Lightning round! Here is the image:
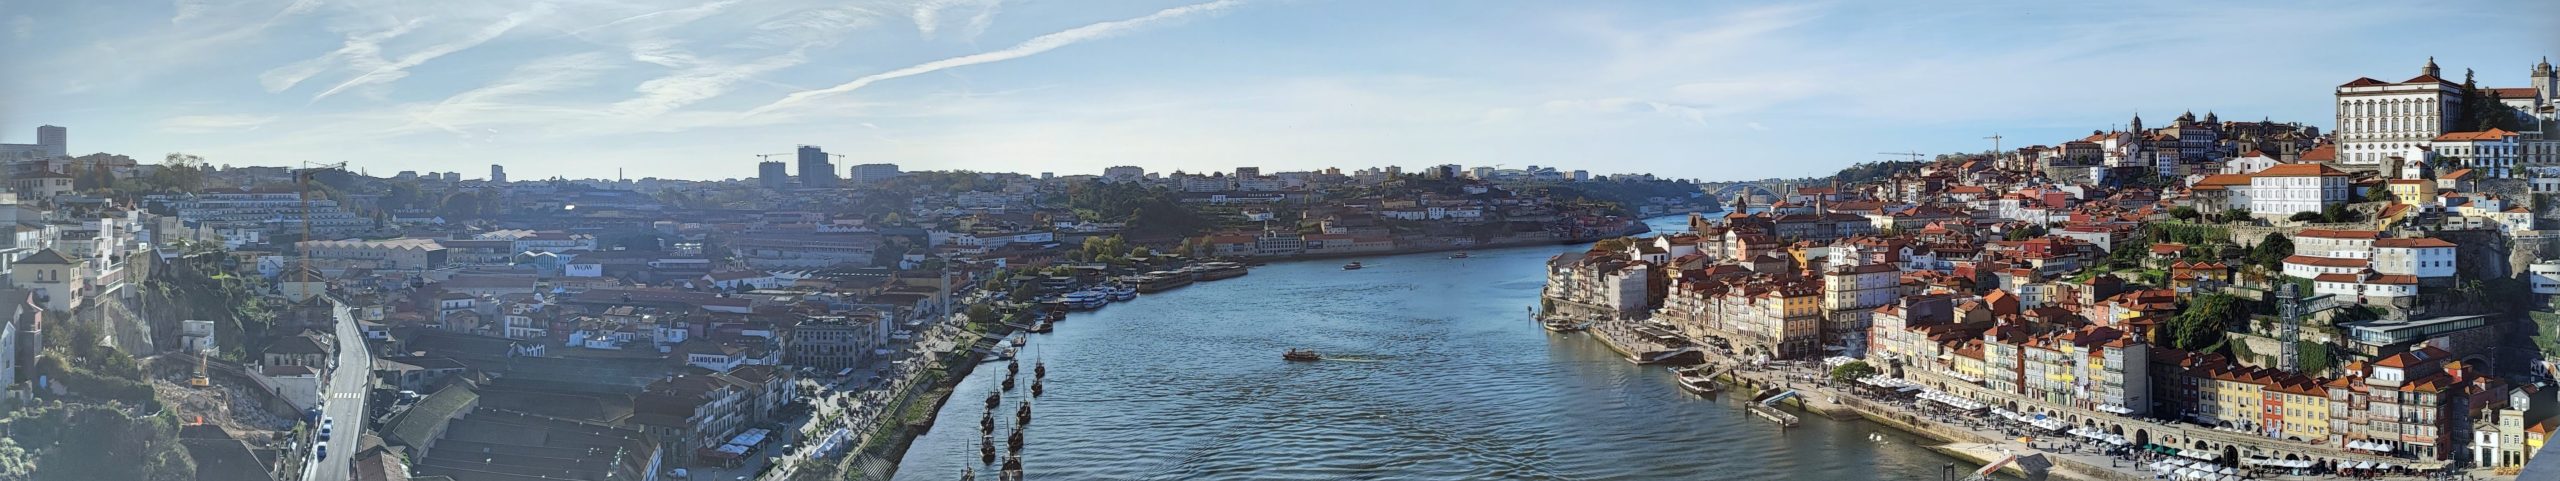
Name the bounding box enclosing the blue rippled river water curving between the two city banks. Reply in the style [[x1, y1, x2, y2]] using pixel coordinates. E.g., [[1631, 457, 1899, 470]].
[[899, 217, 1974, 481]]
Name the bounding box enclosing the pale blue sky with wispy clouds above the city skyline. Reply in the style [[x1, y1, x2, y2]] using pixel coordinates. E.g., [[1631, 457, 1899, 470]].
[[0, 0, 2560, 179]]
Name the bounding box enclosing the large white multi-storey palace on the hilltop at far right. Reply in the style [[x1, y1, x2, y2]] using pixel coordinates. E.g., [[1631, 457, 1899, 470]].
[[2337, 59, 2463, 166]]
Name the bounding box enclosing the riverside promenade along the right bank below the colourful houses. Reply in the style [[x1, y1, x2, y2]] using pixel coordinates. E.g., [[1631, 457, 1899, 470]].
[[1587, 320, 2499, 481]]
